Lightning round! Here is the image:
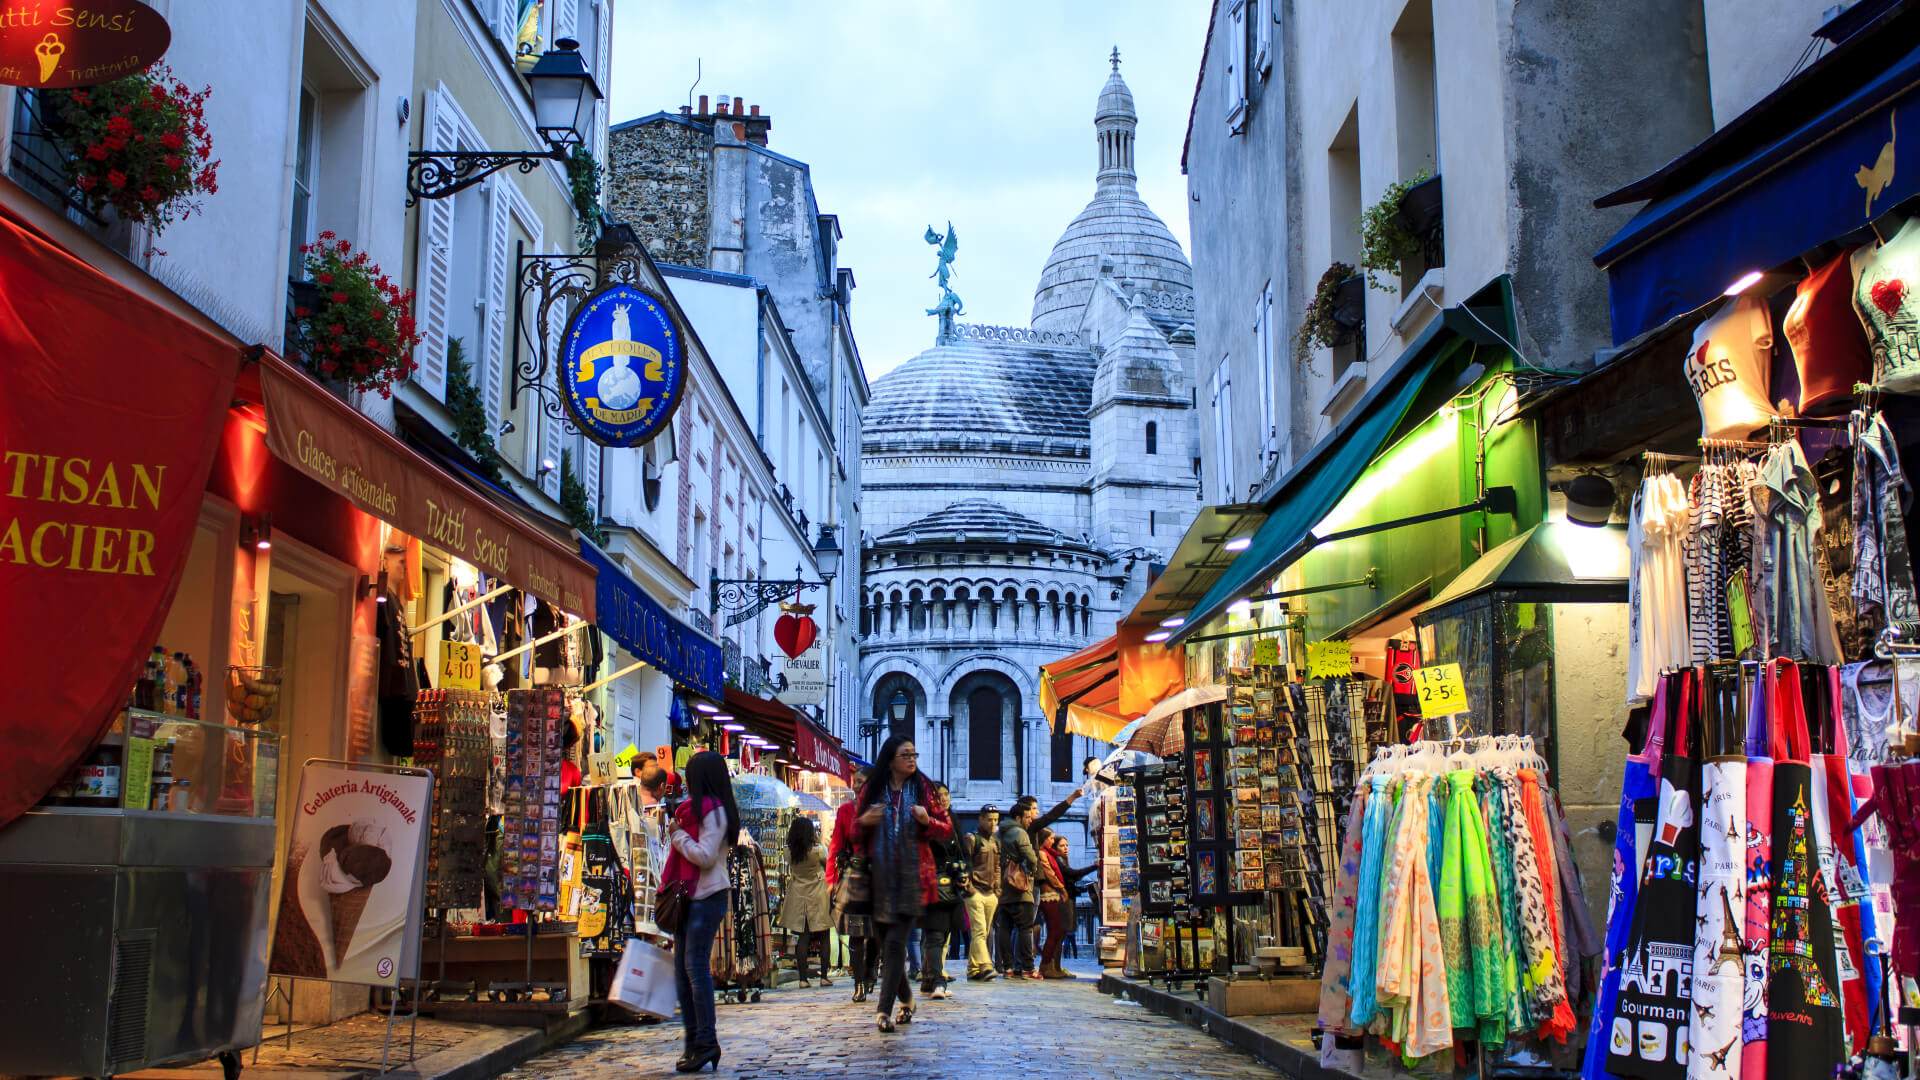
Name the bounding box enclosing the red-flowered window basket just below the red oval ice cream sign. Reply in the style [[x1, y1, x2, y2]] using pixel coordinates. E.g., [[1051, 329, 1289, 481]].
[[42, 65, 221, 234]]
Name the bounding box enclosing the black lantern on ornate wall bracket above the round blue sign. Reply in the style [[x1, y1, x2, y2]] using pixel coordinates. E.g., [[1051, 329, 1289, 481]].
[[407, 38, 601, 206]]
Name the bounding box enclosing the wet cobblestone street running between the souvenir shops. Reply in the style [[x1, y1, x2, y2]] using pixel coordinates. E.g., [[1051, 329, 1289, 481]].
[[505, 965, 1277, 1080]]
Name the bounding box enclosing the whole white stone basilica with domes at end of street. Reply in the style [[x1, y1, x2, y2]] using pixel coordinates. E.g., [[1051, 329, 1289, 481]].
[[854, 54, 1200, 822]]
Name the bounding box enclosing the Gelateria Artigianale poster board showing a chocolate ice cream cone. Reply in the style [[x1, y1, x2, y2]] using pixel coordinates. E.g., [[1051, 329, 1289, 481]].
[[267, 761, 434, 986]]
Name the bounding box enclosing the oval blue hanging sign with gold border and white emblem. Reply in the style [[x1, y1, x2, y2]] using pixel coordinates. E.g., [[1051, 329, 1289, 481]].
[[559, 284, 687, 446]]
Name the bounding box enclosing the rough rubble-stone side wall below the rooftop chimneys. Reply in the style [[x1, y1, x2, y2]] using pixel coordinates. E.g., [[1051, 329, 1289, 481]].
[[607, 117, 712, 267]]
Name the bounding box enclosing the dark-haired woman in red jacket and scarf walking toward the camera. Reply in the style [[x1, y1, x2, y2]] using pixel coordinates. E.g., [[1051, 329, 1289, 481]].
[[856, 734, 954, 1032]]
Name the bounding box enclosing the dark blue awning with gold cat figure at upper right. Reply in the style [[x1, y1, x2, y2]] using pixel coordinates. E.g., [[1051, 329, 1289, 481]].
[[1594, 36, 1920, 344]]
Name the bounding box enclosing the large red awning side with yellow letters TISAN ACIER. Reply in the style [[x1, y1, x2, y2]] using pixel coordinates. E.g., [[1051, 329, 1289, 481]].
[[0, 203, 240, 826]]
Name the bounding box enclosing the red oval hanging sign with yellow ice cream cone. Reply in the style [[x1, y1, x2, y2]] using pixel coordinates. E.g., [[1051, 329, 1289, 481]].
[[0, 0, 173, 90]]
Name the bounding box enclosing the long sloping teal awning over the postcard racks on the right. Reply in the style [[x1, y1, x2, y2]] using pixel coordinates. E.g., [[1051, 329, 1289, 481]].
[[1169, 281, 1511, 644]]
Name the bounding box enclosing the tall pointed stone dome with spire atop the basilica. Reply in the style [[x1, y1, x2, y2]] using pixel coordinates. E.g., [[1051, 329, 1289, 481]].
[[1033, 50, 1194, 331]]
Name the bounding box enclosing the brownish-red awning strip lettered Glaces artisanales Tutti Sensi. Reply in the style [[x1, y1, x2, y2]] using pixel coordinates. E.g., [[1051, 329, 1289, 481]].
[[259, 354, 595, 623]]
